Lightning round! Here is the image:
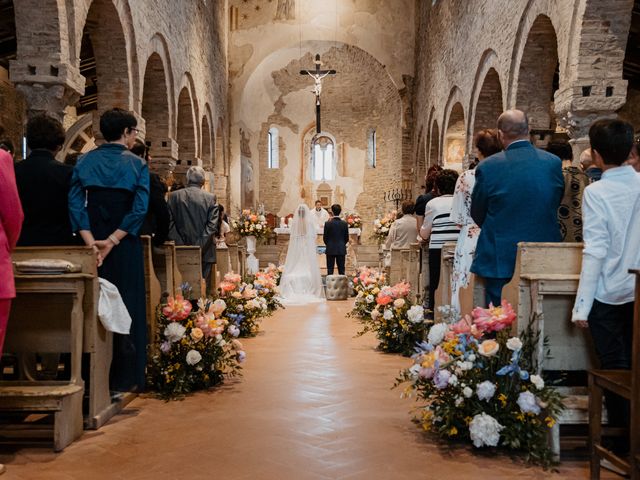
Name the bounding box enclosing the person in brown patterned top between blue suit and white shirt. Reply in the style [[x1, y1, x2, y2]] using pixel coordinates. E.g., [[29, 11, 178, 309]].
[[547, 142, 590, 243]]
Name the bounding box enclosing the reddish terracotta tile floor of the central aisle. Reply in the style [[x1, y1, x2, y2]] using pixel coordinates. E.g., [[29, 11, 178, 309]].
[[0, 302, 604, 480]]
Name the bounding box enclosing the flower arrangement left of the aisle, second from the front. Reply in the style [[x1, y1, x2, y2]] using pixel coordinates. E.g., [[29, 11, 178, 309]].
[[218, 273, 269, 337]]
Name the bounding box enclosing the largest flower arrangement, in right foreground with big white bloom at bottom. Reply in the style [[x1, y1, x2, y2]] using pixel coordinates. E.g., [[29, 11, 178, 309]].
[[396, 301, 563, 466]]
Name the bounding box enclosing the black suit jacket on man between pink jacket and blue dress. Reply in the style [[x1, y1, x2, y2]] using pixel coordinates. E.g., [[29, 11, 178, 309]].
[[15, 150, 83, 246]]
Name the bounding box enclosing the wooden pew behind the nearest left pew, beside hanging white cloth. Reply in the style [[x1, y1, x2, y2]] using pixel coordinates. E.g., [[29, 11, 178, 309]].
[[12, 246, 117, 428]]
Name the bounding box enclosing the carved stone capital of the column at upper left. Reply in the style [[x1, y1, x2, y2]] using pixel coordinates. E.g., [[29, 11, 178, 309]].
[[10, 58, 85, 121]]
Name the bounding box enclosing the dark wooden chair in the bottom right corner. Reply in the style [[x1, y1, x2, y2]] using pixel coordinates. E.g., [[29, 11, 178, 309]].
[[589, 269, 640, 480]]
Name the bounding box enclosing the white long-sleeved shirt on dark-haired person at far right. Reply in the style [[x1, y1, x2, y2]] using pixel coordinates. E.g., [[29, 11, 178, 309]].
[[572, 166, 640, 321]]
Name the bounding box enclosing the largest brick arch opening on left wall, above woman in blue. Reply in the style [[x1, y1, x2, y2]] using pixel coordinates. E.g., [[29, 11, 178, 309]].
[[76, 0, 137, 117]]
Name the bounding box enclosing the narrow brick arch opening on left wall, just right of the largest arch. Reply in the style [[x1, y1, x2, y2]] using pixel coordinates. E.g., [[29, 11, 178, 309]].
[[141, 52, 176, 173]]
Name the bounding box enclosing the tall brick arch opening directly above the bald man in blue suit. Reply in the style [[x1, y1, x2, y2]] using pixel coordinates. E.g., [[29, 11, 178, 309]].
[[515, 15, 559, 132]]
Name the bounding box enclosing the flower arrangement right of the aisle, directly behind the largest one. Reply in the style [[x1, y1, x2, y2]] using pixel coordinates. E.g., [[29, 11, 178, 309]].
[[357, 282, 428, 356]]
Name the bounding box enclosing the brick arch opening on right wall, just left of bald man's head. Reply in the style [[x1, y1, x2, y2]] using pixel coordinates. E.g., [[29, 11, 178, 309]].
[[467, 49, 504, 148]]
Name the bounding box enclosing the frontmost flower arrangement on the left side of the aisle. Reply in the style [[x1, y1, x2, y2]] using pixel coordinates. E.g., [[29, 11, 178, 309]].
[[147, 295, 246, 400]]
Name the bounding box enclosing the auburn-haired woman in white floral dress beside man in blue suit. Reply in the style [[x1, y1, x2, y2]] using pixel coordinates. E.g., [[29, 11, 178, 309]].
[[451, 130, 502, 313]]
